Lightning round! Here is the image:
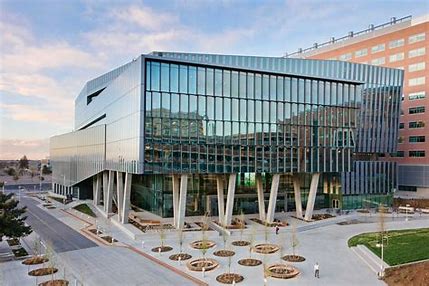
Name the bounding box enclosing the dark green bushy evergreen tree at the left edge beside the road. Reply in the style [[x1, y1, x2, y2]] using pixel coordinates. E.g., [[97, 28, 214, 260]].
[[0, 193, 32, 241]]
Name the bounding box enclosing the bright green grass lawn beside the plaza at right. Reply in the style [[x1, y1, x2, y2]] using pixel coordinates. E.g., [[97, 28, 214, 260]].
[[348, 228, 429, 266]]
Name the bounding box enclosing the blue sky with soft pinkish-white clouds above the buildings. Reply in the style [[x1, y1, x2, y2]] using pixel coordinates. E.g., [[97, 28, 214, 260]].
[[0, 0, 429, 159]]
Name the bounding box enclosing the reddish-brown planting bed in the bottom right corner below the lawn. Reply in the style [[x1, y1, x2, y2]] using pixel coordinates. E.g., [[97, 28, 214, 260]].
[[384, 262, 429, 286]]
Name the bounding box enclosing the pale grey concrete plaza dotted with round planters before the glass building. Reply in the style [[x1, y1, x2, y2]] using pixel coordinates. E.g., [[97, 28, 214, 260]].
[[0, 193, 429, 285]]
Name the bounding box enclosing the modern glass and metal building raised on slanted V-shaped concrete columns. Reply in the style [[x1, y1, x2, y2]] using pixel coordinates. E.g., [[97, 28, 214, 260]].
[[51, 52, 403, 227]]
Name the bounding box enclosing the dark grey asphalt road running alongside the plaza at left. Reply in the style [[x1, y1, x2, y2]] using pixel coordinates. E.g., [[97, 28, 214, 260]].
[[20, 196, 97, 253]]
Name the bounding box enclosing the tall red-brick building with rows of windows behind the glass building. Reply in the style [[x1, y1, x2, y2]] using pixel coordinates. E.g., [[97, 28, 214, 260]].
[[286, 15, 429, 197]]
